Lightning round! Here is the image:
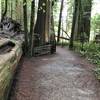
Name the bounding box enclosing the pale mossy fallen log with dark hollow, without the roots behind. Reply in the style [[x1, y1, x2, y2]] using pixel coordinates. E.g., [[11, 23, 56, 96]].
[[0, 38, 22, 100]]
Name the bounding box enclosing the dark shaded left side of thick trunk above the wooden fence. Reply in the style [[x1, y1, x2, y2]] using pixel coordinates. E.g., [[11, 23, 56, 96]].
[[34, 0, 47, 45]]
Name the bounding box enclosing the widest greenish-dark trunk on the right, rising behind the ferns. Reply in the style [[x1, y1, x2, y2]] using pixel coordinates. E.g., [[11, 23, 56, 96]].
[[74, 0, 92, 40]]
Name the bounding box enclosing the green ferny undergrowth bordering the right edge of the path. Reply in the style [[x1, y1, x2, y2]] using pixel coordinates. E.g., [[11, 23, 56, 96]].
[[75, 43, 100, 79]]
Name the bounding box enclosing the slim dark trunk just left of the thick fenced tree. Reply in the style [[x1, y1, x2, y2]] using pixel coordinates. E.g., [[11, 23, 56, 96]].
[[29, 0, 35, 56]]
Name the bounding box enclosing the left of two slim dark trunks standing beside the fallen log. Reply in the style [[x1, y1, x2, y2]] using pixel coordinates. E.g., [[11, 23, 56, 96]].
[[23, 0, 28, 55]]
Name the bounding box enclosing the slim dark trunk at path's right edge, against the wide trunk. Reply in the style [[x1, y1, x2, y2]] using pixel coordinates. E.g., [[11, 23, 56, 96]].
[[69, 0, 78, 49]]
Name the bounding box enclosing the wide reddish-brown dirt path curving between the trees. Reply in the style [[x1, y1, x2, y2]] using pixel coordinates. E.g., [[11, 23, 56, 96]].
[[10, 47, 100, 100]]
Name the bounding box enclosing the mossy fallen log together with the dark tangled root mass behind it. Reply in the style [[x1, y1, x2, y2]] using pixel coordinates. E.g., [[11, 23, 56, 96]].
[[0, 17, 24, 100]]
